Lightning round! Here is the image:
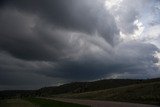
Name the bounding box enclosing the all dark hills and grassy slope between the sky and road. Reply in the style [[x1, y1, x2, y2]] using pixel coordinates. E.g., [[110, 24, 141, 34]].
[[0, 78, 160, 107]]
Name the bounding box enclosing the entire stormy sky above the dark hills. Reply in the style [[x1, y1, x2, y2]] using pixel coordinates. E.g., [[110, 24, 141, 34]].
[[0, 0, 160, 90]]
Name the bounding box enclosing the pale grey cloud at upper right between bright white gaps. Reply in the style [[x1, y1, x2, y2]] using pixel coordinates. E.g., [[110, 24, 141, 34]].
[[109, 0, 151, 36]]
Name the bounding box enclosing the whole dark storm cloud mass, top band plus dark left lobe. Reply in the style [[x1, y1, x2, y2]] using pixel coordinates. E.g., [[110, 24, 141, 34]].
[[0, 0, 118, 60]]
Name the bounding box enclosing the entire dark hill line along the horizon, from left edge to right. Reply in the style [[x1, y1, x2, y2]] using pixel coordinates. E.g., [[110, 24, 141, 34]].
[[0, 78, 160, 99]]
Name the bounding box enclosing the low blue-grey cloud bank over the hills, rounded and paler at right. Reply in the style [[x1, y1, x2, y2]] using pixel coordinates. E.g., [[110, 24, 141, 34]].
[[37, 42, 159, 81]]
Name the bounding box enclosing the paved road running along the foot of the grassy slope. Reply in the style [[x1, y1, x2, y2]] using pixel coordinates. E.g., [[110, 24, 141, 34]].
[[48, 99, 160, 107]]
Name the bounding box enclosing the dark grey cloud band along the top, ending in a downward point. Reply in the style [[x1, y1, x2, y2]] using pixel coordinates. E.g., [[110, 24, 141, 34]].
[[1, 0, 118, 44]]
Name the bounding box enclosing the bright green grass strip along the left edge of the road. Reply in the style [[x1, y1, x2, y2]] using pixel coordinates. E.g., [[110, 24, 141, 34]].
[[27, 98, 88, 107]]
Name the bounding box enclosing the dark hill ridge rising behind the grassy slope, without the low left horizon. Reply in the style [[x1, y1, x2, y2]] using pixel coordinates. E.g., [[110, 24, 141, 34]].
[[36, 78, 160, 96]]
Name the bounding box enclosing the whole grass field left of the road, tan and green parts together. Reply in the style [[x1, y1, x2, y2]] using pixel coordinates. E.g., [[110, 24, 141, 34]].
[[0, 98, 88, 107]]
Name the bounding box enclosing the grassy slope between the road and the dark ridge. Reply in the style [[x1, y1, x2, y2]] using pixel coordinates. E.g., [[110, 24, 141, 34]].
[[56, 82, 160, 105]]
